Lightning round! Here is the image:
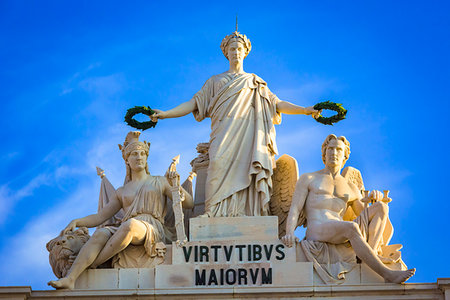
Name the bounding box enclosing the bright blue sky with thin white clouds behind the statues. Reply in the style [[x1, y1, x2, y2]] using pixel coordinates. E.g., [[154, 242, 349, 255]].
[[0, 1, 450, 289]]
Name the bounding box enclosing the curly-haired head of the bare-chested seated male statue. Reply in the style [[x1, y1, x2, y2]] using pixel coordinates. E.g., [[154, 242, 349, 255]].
[[322, 134, 350, 168]]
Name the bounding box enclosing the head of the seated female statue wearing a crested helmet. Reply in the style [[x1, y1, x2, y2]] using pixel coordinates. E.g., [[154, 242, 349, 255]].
[[119, 131, 150, 183]]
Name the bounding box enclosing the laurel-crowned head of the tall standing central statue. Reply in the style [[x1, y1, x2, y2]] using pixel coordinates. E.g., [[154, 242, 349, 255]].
[[220, 31, 252, 62]]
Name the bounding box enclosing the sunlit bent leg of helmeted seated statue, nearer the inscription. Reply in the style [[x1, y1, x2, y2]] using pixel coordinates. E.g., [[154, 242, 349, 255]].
[[92, 219, 147, 267]]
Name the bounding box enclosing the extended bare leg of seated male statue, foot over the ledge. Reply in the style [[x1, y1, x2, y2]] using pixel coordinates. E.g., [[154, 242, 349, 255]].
[[307, 221, 416, 283]]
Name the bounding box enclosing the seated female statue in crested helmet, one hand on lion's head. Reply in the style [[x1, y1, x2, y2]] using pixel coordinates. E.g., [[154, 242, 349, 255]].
[[48, 131, 193, 289]]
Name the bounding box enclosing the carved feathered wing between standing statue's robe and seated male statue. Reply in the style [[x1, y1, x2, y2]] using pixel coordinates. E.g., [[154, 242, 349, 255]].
[[270, 154, 298, 237]]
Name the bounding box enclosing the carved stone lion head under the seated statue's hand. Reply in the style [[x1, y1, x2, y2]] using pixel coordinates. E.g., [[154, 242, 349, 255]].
[[47, 227, 89, 278]]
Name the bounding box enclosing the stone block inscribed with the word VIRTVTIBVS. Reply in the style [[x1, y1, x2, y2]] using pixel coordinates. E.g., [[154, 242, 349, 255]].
[[172, 239, 296, 265]]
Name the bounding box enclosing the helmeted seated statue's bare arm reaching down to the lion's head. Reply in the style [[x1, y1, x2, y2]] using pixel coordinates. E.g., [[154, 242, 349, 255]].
[[64, 189, 122, 232]]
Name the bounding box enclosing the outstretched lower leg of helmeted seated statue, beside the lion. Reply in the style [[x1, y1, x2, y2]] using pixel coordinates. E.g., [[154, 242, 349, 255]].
[[48, 228, 111, 289]]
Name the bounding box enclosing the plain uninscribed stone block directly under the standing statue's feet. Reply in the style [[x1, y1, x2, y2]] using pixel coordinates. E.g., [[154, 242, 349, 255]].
[[189, 216, 278, 241]]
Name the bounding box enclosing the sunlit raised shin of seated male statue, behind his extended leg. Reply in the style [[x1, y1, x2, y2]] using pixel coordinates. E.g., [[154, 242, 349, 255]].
[[367, 202, 389, 252]]
